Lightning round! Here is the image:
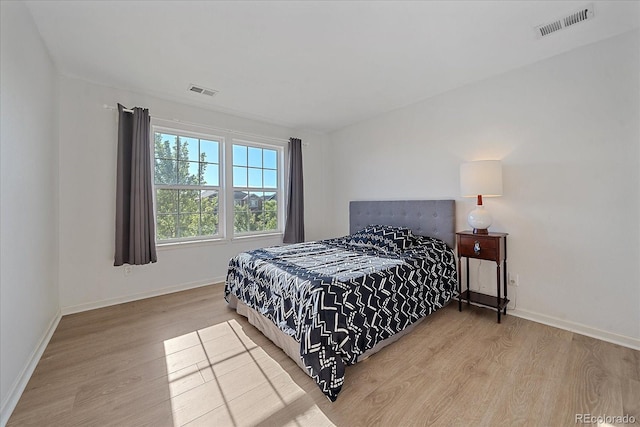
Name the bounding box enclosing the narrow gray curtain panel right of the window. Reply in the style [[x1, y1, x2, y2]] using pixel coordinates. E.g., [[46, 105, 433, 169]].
[[283, 138, 304, 243]]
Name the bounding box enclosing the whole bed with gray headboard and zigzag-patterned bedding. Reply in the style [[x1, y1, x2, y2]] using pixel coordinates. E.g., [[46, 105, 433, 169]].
[[225, 200, 457, 401]]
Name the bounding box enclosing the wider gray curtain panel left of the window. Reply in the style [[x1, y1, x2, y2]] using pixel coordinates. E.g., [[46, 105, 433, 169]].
[[113, 104, 158, 266]]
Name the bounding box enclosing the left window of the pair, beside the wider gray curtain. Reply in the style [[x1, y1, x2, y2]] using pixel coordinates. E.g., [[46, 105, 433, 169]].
[[154, 131, 222, 241]]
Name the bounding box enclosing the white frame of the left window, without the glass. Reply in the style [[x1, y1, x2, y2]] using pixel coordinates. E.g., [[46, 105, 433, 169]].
[[150, 124, 226, 246]]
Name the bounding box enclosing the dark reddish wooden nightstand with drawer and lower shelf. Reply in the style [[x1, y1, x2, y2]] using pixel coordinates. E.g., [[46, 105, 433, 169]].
[[456, 231, 509, 323]]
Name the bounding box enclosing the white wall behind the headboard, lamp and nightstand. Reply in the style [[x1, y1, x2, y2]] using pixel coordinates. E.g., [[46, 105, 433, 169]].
[[329, 31, 640, 346]]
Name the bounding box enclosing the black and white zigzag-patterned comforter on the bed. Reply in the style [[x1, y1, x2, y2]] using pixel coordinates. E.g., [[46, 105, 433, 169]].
[[225, 235, 457, 401]]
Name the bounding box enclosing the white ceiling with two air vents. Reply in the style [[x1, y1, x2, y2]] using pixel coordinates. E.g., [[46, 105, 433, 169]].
[[26, 0, 640, 132]]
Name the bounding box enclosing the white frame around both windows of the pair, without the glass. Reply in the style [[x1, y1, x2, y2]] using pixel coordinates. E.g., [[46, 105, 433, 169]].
[[149, 118, 289, 247]]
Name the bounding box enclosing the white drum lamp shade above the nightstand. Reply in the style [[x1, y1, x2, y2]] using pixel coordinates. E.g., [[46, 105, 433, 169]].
[[460, 160, 502, 197]]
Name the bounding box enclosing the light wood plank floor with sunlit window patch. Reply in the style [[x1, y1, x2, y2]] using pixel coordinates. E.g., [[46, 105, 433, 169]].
[[8, 285, 640, 426]]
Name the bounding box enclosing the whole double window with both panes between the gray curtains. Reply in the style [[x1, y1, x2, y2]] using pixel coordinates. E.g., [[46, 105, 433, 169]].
[[153, 123, 286, 243]]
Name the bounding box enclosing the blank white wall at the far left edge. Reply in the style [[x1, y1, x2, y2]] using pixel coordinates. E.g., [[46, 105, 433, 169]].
[[0, 1, 59, 425]]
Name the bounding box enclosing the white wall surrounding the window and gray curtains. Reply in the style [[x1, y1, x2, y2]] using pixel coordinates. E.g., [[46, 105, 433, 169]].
[[60, 77, 326, 313]]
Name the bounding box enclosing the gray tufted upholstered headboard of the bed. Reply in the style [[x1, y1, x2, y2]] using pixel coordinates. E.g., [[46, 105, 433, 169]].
[[349, 200, 456, 248]]
